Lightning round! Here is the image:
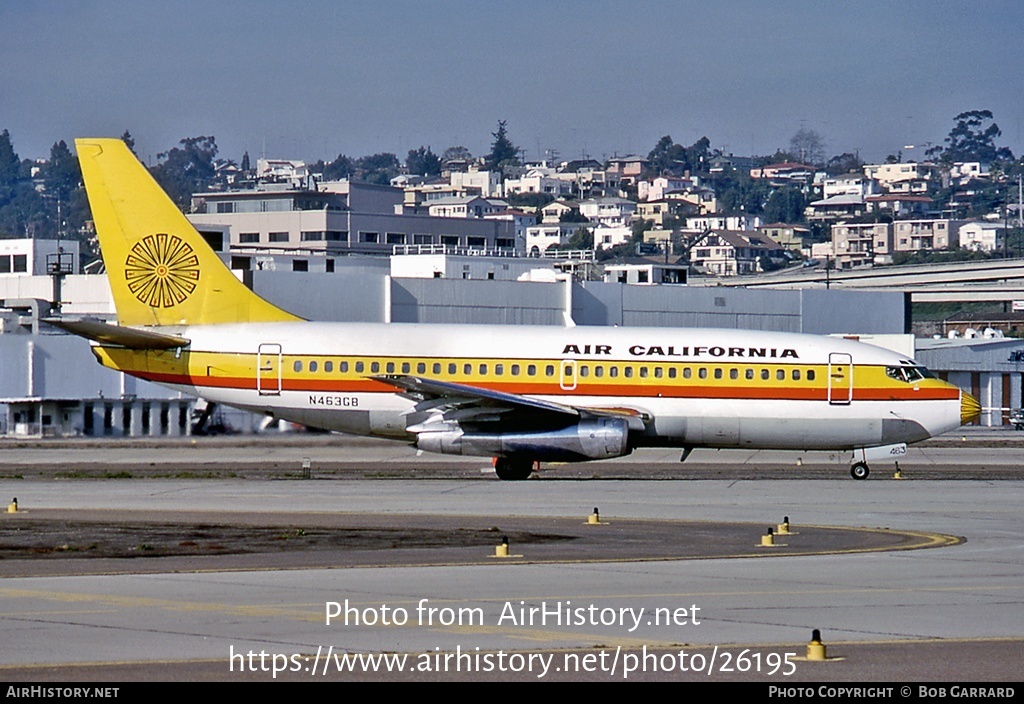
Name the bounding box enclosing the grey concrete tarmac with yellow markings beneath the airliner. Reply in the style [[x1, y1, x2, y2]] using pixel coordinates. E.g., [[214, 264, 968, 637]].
[[0, 434, 1024, 686]]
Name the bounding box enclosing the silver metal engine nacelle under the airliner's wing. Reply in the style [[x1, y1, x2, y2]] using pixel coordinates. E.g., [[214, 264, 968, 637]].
[[416, 417, 632, 461]]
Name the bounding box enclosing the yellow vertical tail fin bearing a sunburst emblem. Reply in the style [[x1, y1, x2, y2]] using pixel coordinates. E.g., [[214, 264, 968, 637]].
[[75, 139, 301, 325]]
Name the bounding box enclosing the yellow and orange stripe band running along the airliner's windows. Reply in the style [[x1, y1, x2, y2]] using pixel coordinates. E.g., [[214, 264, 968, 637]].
[[95, 347, 956, 401]]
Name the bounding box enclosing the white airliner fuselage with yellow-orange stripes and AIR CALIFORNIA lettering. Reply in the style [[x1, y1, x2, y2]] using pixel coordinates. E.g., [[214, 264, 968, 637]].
[[103, 322, 961, 449]]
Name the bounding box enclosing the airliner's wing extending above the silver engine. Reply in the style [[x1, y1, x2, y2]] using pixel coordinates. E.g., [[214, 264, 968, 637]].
[[373, 375, 649, 432]]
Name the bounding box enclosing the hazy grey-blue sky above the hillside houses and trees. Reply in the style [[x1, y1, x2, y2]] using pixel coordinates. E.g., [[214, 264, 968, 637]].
[[0, 0, 1024, 166]]
